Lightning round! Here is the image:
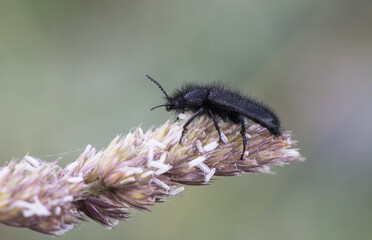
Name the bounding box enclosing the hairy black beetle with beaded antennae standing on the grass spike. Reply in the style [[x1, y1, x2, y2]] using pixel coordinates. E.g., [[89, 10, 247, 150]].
[[146, 75, 281, 160]]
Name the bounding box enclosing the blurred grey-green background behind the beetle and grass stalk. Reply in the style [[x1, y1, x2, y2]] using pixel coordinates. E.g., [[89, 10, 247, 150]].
[[0, 0, 372, 240]]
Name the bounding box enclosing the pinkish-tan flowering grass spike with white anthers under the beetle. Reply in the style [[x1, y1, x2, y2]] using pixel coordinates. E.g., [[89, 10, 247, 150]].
[[0, 115, 303, 235]]
